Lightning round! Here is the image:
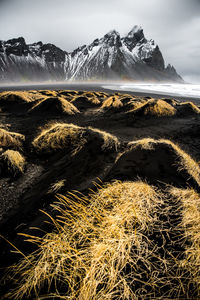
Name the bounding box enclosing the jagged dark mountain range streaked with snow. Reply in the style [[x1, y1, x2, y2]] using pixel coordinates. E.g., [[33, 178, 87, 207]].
[[0, 26, 182, 82]]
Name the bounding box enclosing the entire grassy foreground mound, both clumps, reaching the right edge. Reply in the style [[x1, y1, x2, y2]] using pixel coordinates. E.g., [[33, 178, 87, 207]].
[[6, 181, 200, 300]]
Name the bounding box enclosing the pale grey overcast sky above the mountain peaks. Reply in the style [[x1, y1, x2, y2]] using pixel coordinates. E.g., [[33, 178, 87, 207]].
[[0, 0, 200, 84]]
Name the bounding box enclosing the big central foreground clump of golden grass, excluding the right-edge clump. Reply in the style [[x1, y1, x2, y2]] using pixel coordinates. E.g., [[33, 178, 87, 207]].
[[6, 182, 166, 300]]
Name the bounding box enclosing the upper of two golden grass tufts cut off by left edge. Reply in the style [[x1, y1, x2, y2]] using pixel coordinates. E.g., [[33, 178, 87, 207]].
[[0, 128, 25, 148]]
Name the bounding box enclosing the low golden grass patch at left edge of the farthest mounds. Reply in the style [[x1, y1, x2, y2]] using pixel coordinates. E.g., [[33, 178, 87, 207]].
[[0, 91, 41, 103]]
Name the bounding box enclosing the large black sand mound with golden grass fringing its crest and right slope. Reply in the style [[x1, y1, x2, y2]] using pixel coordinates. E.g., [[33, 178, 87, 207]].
[[107, 138, 200, 188]]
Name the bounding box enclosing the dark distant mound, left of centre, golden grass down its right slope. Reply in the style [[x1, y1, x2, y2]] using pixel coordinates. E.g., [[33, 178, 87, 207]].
[[29, 97, 79, 115]]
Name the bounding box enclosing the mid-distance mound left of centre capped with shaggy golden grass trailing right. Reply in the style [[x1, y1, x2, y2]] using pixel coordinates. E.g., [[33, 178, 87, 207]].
[[32, 123, 119, 154]]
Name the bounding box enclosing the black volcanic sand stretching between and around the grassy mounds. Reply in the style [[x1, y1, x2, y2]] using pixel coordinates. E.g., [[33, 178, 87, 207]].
[[0, 87, 200, 298]]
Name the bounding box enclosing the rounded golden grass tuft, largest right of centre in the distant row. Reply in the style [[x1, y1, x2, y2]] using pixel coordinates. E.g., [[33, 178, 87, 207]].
[[130, 99, 176, 117]]
